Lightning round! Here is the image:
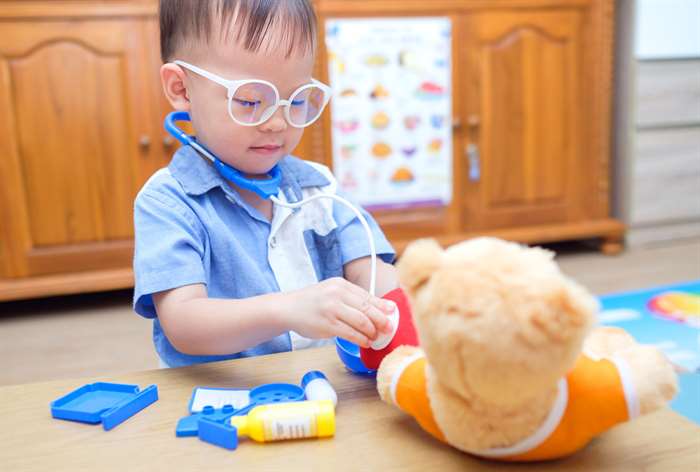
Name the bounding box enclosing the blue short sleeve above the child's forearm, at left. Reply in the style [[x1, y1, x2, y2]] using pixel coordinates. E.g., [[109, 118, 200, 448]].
[[134, 192, 206, 318]]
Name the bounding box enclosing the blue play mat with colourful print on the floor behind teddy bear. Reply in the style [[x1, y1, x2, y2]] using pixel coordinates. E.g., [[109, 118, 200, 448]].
[[598, 280, 700, 424]]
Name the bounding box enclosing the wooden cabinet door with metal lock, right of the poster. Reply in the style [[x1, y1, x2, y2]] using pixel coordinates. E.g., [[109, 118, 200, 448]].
[[461, 7, 588, 230]]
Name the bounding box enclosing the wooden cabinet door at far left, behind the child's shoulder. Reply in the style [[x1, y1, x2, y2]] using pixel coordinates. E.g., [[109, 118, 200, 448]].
[[0, 18, 150, 277]]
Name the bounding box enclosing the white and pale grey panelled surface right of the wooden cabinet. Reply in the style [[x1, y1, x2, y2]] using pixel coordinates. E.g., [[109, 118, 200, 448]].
[[628, 0, 700, 245]]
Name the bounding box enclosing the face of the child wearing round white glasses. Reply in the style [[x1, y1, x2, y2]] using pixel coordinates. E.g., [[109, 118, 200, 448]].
[[171, 36, 313, 175]]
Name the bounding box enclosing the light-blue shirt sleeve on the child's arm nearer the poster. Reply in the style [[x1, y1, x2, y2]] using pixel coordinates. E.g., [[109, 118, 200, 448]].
[[333, 192, 396, 265]]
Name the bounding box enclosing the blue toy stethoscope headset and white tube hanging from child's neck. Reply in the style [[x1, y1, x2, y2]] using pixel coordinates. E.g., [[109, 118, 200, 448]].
[[163, 111, 377, 296]]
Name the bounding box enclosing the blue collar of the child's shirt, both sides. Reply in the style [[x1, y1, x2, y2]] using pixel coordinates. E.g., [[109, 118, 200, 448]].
[[168, 146, 330, 198]]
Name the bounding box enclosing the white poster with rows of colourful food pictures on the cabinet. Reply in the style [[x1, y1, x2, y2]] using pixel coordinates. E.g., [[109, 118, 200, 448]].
[[325, 17, 452, 209]]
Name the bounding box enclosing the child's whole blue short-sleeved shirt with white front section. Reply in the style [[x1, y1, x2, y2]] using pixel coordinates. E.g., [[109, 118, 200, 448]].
[[134, 146, 395, 367]]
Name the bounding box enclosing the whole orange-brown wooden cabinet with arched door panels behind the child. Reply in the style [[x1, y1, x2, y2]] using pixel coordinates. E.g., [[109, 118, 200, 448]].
[[0, 0, 623, 300]]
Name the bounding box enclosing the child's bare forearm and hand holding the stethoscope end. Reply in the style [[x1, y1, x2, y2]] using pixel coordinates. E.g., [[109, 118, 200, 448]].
[[153, 278, 394, 355]]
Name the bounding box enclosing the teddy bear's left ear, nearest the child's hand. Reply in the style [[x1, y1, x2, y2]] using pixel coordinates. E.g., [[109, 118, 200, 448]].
[[397, 239, 444, 292]]
